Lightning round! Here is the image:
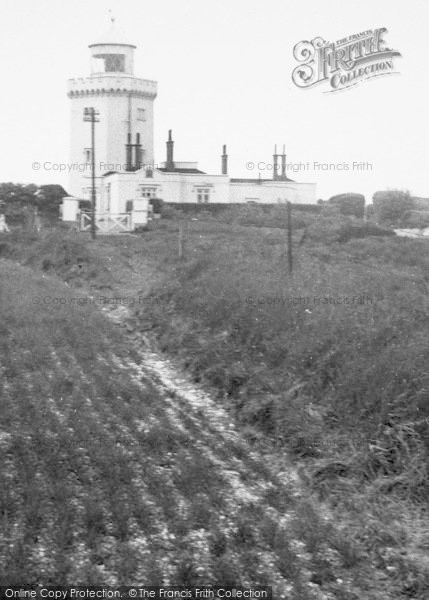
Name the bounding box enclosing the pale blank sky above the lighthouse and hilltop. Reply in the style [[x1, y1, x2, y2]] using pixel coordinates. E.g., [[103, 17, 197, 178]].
[[0, 0, 429, 202]]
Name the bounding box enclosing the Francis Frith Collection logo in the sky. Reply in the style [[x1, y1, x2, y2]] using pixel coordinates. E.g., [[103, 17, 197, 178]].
[[292, 27, 401, 93]]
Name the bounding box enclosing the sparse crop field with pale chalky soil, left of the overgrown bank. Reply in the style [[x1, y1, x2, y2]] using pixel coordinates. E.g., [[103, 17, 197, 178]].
[[0, 260, 368, 598]]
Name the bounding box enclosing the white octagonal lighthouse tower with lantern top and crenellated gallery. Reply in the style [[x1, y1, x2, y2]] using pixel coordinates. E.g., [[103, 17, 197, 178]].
[[68, 18, 157, 203]]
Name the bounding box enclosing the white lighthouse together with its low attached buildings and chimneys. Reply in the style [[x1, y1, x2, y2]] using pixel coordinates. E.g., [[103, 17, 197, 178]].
[[68, 20, 316, 227]]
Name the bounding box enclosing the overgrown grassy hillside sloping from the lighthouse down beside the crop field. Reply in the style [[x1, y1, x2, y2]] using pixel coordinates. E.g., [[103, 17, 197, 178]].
[[2, 213, 429, 600]]
